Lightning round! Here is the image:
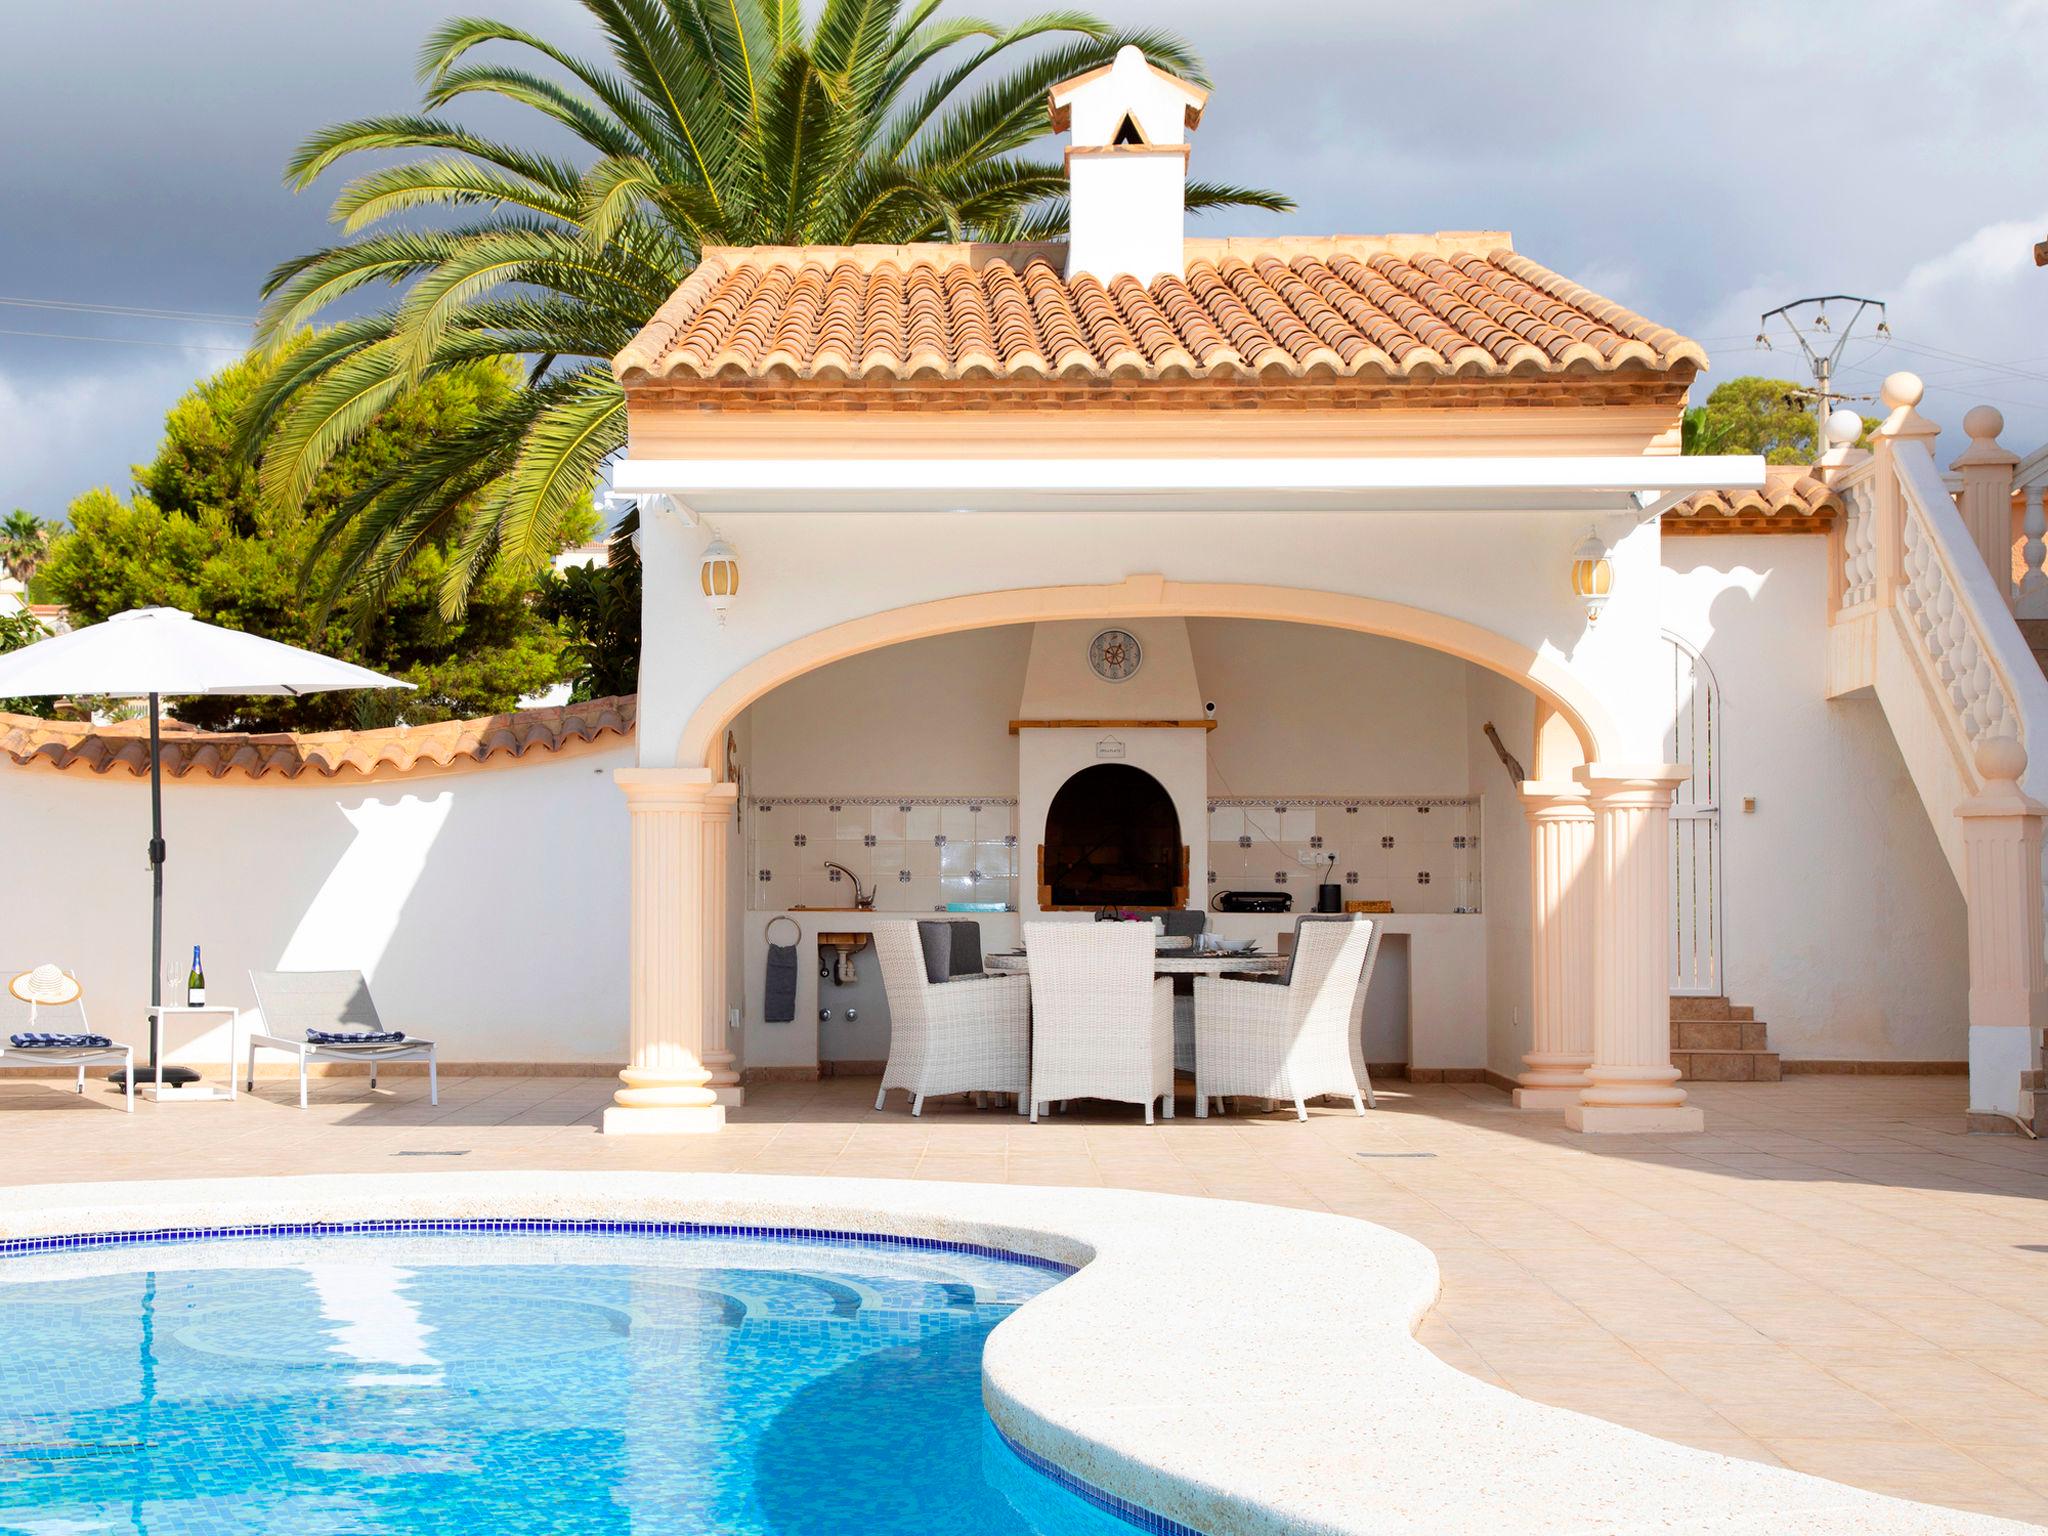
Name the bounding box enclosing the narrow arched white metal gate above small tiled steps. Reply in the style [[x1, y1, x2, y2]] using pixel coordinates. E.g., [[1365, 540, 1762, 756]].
[[1665, 633, 1726, 997]]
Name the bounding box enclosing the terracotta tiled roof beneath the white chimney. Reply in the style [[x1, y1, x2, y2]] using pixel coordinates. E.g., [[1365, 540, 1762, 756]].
[[612, 233, 1706, 387]]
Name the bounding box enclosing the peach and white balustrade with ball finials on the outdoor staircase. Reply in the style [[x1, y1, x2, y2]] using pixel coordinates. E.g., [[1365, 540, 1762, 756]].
[[1821, 373, 2048, 1130]]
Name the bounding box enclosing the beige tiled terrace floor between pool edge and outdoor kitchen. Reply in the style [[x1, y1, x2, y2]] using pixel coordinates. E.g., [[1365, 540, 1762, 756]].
[[0, 1077, 2048, 1524]]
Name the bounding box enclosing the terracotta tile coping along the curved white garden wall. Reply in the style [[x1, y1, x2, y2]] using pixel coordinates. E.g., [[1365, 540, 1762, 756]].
[[0, 694, 635, 778]]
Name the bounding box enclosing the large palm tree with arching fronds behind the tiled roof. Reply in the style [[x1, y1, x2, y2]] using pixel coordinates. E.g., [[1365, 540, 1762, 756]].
[[244, 0, 1292, 614]]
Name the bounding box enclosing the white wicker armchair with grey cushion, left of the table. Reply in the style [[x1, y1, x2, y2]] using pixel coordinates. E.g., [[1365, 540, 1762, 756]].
[[874, 922, 1030, 1114]]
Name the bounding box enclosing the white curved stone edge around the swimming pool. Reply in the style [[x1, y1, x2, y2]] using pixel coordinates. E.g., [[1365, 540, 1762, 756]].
[[0, 1171, 2036, 1536]]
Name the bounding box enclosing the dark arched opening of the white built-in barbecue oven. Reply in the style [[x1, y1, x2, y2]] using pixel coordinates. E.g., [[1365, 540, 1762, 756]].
[[1038, 762, 1188, 911]]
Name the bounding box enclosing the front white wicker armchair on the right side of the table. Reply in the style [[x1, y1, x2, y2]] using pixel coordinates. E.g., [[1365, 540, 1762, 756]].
[[1194, 920, 1374, 1120]]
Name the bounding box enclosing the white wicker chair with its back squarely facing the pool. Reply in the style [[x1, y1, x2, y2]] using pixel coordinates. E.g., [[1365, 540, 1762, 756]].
[[1024, 924, 1174, 1124]]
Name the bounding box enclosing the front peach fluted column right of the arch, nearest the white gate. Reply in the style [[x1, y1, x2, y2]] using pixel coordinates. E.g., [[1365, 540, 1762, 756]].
[[1565, 764, 1706, 1130]]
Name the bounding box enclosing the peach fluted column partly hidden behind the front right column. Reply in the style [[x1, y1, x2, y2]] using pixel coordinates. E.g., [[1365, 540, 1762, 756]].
[[1516, 784, 1593, 1110]]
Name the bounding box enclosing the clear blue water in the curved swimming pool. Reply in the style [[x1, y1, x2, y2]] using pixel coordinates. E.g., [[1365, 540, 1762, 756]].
[[0, 1233, 1133, 1536]]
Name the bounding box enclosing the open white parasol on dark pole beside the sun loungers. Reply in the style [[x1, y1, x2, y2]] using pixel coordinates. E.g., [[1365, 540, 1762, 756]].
[[0, 608, 412, 1081]]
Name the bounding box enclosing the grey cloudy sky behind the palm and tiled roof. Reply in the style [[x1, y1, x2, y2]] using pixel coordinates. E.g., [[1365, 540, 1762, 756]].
[[0, 0, 2048, 516]]
